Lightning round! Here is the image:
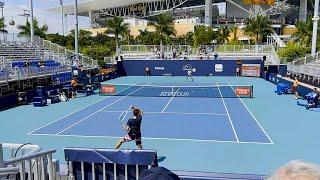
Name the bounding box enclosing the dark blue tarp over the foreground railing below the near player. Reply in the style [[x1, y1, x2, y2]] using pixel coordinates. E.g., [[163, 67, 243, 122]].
[[64, 148, 158, 180]]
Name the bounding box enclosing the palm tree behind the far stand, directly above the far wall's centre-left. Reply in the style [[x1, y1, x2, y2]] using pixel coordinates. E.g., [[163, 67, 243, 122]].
[[149, 13, 176, 52]]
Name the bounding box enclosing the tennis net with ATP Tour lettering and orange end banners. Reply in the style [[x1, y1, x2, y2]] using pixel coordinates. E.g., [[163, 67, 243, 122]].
[[100, 84, 253, 98]]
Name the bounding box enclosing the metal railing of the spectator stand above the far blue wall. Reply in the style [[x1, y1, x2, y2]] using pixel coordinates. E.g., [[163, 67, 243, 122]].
[[121, 45, 280, 65]]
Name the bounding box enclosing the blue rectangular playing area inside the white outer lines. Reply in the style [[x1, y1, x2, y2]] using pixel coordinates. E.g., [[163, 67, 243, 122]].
[[29, 79, 272, 144]]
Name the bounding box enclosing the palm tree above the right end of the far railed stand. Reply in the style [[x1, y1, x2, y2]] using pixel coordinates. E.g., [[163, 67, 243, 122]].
[[245, 15, 273, 44]]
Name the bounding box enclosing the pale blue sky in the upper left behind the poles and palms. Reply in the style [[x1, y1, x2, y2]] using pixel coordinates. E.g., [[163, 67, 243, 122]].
[[1, 0, 89, 34]]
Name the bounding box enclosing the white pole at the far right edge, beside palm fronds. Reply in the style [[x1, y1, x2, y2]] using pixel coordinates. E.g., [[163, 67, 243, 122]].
[[311, 0, 319, 56]]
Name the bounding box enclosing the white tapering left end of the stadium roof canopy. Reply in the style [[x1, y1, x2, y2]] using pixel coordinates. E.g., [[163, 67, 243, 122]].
[[47, 0, 163, 14]]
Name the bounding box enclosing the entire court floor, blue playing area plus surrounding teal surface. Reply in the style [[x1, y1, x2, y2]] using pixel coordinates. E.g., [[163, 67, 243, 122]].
[[0, 77, 320, 175]]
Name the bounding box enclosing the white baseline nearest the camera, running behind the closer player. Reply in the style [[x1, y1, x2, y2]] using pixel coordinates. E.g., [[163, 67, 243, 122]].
[[30, 134, 271, 145]]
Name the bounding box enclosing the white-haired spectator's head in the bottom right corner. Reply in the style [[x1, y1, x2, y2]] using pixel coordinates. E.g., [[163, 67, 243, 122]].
[[267, 161, 320, 180]]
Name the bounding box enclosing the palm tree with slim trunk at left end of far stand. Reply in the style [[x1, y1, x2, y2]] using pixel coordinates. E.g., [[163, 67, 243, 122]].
[[107, 17, 129, 56]]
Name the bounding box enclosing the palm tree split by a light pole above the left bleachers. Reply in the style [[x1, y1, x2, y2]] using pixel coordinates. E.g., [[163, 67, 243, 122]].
[[18, 19, 48, 38]]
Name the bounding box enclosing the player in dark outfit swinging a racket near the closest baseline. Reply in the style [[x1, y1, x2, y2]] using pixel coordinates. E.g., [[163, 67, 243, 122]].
[[115, 107, 143, 149]]
